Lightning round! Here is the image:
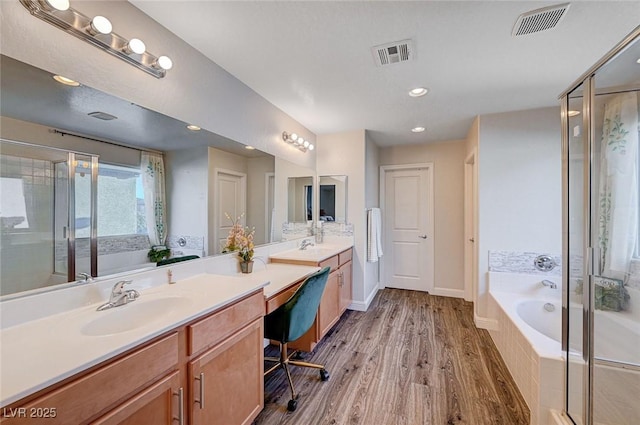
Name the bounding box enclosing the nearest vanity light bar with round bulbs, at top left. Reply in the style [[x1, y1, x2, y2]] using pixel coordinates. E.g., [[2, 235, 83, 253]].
[[20, 0, 173, 78]]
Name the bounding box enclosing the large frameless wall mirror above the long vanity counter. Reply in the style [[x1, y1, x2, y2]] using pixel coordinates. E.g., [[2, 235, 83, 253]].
[[0, 55, 286, 295]]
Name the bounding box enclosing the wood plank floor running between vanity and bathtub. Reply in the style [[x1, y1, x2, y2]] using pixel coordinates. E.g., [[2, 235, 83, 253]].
[[254, 289, 529, 425]]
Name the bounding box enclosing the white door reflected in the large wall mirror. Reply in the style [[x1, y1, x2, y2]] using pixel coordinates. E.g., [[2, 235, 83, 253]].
[[214, 169, 247, 254]]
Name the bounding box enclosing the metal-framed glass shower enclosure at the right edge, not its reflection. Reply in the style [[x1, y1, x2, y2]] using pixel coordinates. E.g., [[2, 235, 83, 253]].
[[561, 27, 640, 425]]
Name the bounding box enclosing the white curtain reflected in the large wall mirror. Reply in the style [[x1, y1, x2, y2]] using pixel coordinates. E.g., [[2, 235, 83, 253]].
[[140, 152, 167, 245]]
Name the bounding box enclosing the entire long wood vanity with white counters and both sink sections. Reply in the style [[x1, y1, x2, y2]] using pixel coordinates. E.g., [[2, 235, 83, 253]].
[[0, 240, 352, 425]]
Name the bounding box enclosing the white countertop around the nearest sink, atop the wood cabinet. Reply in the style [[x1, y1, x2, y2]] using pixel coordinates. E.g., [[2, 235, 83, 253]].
[[0, 273, 269, 406]]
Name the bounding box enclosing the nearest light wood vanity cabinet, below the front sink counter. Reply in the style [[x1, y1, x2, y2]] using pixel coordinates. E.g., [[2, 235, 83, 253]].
[[0, 290, 264, 425]]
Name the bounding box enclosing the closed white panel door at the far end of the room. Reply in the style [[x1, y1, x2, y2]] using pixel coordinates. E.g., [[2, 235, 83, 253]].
[[383, 166, 433, 292]]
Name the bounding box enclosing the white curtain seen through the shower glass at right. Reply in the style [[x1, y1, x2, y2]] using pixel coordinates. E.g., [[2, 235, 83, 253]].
[[598, 93, 638, 280]]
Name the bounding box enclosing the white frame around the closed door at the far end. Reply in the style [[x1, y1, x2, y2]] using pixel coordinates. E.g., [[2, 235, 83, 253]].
[[379, 162, 436, 294]]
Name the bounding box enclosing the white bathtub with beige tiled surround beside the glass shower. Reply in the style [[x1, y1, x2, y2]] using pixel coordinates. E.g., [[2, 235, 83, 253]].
[[489, 272, 640, 425]]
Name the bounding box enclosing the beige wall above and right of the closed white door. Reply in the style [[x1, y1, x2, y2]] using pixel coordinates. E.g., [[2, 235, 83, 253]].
[[380, 140, 467, 298]]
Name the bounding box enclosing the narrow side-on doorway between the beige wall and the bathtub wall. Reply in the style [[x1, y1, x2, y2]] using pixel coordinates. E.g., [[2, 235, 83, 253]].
[[464, 148, 479, 304]]
